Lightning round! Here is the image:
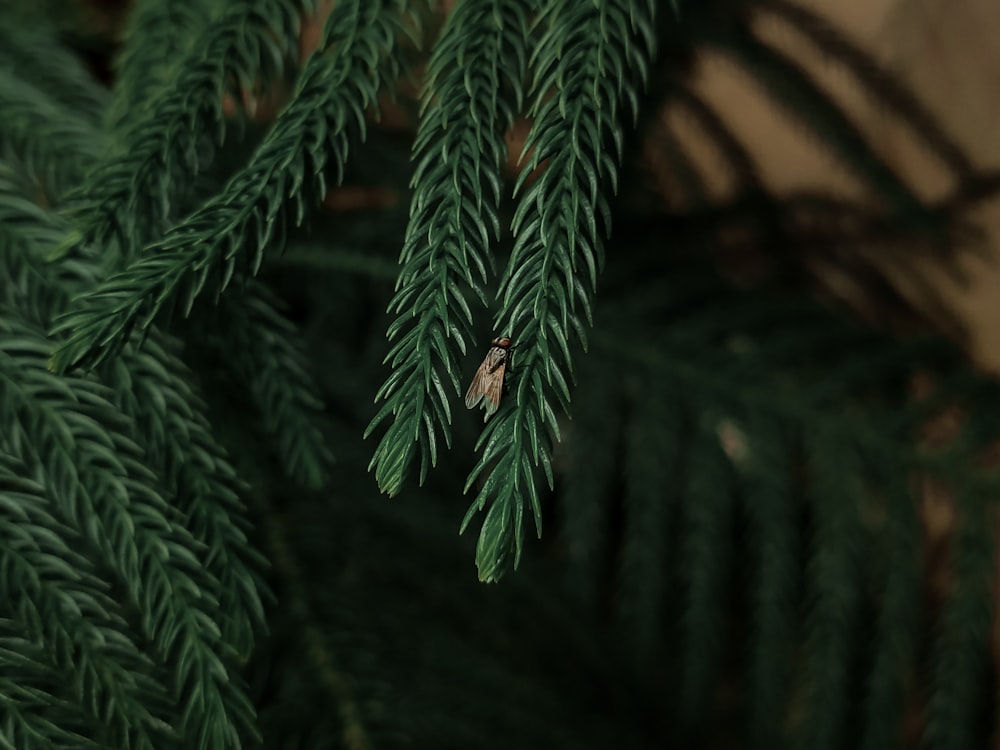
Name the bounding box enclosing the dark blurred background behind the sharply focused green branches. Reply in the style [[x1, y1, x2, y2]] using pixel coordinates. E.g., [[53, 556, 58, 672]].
[[0, 0, 1000, 750]]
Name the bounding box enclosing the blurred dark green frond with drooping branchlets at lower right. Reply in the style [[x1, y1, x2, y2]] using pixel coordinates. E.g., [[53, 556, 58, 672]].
[[584, 258, 1000, 747]]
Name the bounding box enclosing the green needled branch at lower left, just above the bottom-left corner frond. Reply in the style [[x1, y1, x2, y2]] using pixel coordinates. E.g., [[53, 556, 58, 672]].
[[0, 453, 167, 750]]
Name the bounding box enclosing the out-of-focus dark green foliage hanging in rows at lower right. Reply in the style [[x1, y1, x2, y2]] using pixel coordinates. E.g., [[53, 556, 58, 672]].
[[580, 267, 997, 747]]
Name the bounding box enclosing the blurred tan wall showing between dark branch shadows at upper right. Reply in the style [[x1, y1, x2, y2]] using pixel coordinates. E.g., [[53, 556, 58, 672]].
[[699, 0, 1000, 373]]
